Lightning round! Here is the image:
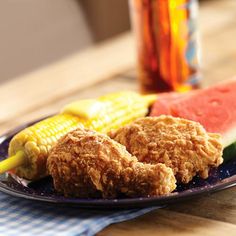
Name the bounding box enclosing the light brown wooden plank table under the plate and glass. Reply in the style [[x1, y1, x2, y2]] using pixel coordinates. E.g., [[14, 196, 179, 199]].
[[0, 0, 236, 236]]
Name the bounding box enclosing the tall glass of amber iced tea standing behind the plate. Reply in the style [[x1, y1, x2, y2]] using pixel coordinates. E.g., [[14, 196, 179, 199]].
[[130, 0, 201, 93]]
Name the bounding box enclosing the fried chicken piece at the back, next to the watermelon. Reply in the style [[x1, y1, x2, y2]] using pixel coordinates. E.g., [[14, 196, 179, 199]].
[[109, 115, 223, 183]]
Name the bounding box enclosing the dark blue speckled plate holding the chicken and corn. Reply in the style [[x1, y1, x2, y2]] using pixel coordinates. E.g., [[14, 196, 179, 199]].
[[0, 121, 236, 209]]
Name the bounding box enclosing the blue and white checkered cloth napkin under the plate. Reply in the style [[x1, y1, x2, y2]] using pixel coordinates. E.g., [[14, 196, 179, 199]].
[[0, 192, 155, 236]]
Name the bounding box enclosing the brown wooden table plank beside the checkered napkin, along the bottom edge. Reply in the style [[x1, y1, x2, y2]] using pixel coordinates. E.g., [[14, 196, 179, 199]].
[[98, 209, 236, 236]]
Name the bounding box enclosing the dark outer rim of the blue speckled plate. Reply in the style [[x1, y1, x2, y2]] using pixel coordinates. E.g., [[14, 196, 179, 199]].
[[0, 121, 236, 208]]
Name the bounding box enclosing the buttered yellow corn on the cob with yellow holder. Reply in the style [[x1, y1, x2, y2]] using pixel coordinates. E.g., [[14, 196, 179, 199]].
[[0, 92, 156, 180]]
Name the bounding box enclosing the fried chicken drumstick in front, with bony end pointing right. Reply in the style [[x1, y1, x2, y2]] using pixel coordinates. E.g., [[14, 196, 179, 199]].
[[47, 129, 176, 198]]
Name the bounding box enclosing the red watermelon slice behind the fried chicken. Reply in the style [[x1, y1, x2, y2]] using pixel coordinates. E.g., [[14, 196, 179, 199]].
[[151, 78, 236, 147]]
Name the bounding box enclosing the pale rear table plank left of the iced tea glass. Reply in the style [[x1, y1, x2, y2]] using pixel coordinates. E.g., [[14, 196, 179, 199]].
[[0, 34, 135, 124]]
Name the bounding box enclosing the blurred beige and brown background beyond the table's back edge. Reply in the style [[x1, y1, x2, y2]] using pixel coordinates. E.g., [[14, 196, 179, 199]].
[[0, 0, 236, 82]]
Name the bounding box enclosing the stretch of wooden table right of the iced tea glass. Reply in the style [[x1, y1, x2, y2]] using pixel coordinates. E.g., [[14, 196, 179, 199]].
[[199, 0, 236, 86]]
